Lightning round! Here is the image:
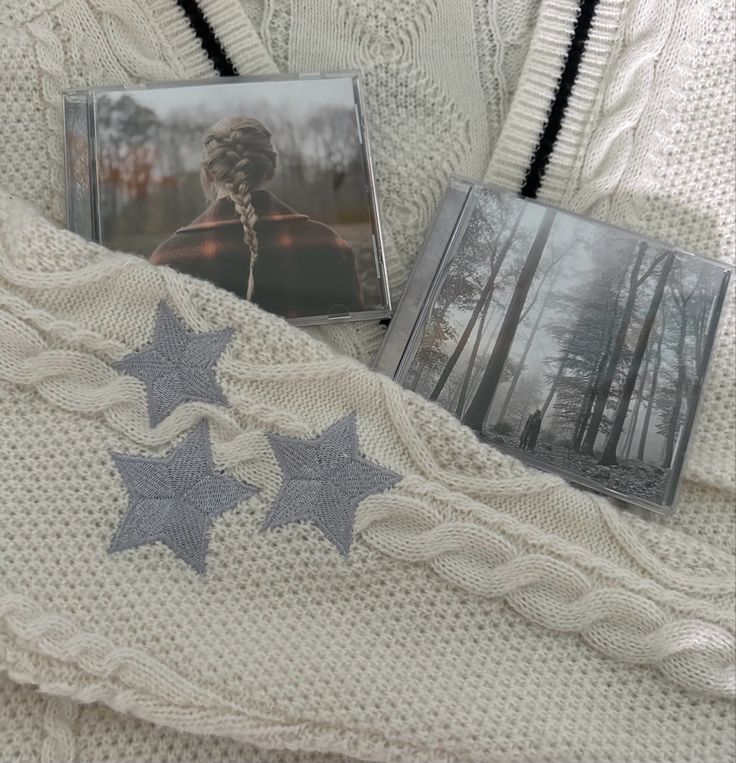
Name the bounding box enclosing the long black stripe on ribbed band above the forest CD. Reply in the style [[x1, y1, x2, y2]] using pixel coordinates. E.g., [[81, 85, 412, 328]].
[[521, 0, 598, 199]]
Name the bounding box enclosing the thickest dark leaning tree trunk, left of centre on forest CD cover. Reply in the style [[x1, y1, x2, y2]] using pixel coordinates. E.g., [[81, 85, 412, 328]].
[[463, 209, 556, 432]]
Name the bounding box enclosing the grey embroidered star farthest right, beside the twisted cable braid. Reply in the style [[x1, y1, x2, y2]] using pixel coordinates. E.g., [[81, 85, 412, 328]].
[[262, 413, 401, 556]]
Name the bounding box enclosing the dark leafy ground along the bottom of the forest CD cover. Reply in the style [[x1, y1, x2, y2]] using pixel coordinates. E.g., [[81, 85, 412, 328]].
[[483, 433, 670, 504]]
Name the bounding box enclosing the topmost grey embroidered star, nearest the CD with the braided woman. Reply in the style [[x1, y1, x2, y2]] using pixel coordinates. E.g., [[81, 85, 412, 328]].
[[112, 302, 233, 426]]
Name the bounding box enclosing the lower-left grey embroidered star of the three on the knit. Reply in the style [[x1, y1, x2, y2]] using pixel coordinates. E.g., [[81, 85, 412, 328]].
[[110, 422, 258, 574]]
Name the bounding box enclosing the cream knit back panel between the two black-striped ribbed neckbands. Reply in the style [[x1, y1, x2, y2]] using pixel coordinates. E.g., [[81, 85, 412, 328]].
[[261, 0, 537, 296]]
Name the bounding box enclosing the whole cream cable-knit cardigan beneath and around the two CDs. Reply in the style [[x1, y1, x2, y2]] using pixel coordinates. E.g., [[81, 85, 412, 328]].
[[0, 0, 736, 763]]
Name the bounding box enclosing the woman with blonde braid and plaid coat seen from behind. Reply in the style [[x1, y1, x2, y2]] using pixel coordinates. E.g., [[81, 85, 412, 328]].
[[150, 116, 364, 318]]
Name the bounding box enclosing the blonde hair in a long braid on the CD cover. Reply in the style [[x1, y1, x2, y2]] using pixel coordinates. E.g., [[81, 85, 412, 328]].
[[200, 116, 276, 299]]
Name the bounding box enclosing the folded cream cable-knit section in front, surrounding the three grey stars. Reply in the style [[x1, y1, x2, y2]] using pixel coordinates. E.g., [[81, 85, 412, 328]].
[[0, 198, 735, 761]]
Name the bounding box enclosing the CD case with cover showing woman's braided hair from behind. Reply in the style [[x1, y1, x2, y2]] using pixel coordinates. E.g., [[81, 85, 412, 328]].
[[64, 68, 391, 325]]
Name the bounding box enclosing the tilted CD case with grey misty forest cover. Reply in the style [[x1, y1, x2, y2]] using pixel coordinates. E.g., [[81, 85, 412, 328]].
[[376, 179, 733, 513]]
